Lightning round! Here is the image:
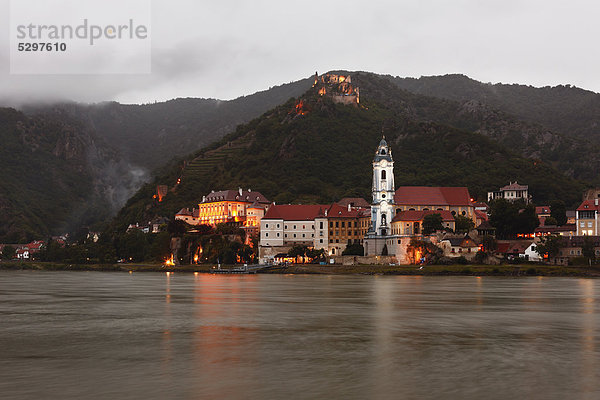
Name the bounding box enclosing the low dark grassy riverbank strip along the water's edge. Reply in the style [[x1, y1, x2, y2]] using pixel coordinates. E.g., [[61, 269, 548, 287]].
[[0, 261, 600, 278]]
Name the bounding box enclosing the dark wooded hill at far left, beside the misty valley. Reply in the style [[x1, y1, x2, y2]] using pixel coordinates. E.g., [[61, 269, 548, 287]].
[[0, 108, 141, 243]]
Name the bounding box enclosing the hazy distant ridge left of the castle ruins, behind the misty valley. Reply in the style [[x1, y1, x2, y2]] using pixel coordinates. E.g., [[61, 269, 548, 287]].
[[24, 79, 312, 170]]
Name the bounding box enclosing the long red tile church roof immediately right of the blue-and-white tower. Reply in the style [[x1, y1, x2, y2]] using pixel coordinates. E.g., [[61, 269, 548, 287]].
[[394, 186, 473, 206]]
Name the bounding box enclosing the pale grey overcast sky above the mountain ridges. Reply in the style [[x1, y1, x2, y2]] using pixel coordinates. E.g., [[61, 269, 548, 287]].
[[0, 0, 600, 103]]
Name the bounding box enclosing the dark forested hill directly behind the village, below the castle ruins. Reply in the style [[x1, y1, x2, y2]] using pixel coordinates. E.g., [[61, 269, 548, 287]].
[[110, 73, 586, 231]]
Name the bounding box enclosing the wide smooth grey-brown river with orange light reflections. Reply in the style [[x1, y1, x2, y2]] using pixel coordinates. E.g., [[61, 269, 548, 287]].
[[0, 271, 600, 399]]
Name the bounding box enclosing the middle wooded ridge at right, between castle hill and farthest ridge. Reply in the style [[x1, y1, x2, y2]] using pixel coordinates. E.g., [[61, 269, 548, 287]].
[[358, 76, 600, 185]]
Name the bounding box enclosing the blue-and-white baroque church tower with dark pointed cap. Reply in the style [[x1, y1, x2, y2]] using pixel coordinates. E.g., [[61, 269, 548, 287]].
[[369, 136, 395, 236]]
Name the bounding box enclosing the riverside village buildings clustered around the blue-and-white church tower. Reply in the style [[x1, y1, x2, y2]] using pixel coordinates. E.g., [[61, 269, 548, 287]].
[[163, 137, 600, 265]]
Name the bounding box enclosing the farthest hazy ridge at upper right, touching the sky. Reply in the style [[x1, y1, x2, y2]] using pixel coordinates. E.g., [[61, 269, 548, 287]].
[[392, 74, 600, 144]]
